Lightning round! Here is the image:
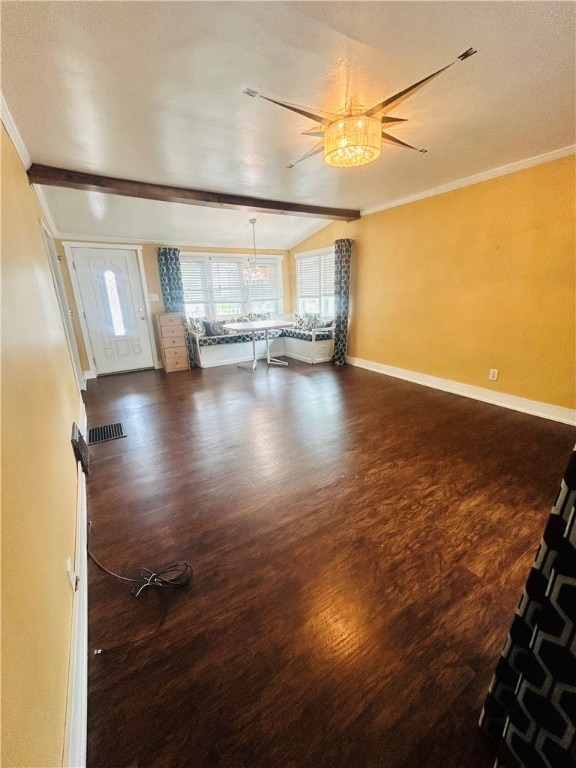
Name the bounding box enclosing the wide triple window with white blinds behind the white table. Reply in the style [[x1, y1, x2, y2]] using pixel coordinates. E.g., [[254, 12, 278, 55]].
[[180, 253, 283, 319]]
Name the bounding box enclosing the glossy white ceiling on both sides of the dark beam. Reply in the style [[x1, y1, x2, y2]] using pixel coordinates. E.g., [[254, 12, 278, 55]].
[[0, 1, 575, 248]]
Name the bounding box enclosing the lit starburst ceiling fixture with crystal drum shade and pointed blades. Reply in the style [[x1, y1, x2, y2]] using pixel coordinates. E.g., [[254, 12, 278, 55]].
[[244, 48, 477, 168]]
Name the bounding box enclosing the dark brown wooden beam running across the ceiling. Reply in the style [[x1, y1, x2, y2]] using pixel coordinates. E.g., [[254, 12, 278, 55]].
[[28, 163, 360, 221]]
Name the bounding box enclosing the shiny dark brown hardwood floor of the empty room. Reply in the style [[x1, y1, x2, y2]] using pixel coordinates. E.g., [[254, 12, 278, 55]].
[[86, 360, 575, 768]]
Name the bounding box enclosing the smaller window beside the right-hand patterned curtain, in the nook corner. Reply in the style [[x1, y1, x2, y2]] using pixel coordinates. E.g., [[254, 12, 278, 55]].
[[296, 248, 334, 316]]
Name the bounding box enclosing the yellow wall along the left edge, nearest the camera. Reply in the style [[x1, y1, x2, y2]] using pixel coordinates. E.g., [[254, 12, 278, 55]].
[[1, 128, 81, 768]]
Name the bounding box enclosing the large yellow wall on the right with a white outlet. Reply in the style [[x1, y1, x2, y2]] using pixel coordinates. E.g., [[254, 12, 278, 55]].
[[290, 156, 576, 408]]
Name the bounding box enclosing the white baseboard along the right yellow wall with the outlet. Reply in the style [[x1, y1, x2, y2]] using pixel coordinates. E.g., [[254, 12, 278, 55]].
[[346, 357, 576, 426]]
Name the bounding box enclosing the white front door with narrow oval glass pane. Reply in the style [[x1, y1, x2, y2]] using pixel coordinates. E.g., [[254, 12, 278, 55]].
[[70, 245, 154, 374]]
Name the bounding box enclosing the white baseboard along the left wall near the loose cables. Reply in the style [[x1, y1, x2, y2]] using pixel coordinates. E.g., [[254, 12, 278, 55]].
[[63, 405, 88, 768]]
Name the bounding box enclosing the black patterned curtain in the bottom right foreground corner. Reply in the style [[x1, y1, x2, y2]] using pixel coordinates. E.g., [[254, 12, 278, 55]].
[[480, 448, 576, 768]]
